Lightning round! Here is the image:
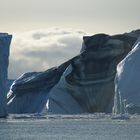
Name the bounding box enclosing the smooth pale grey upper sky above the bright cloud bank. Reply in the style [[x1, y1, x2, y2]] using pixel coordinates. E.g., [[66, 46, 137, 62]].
[[0, 0, 140, 34]]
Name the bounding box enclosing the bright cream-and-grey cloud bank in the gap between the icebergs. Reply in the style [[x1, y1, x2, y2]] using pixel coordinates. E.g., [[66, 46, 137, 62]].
[[9, 28, 86, 78]]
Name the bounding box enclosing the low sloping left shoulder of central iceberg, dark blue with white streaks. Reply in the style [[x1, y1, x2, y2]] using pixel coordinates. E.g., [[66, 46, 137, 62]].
[[7, 61, 70, 113]]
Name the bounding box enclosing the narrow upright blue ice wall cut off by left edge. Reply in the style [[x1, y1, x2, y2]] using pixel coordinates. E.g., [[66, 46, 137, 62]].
[[0, 33, 12, 117]]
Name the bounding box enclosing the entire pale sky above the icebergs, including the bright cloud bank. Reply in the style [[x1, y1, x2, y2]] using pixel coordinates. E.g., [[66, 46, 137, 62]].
[[0, 0, 140, 79]]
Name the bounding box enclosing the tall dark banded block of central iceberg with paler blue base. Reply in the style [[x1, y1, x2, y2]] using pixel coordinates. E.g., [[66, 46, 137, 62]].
[[48, 34, 138, 114]]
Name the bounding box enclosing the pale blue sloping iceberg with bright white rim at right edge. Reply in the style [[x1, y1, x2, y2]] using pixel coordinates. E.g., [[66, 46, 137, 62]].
[[114, 38, 140, 114]]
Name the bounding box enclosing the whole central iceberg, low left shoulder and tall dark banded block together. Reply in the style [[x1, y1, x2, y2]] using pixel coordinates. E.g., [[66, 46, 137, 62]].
[[7, 31, 139, 114]]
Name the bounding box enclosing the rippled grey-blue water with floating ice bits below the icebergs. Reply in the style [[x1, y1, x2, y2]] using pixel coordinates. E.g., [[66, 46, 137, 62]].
[[0, 114, 140, 140]]
